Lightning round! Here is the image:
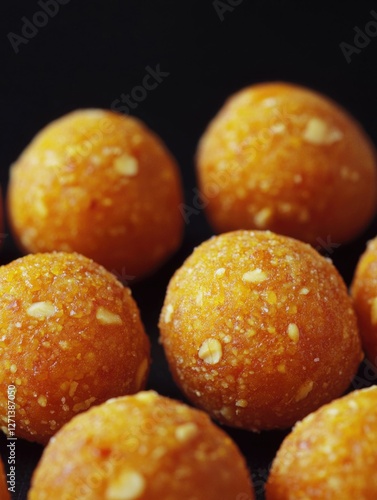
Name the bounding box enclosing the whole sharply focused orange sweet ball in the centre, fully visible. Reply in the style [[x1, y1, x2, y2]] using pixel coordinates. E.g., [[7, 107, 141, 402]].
[[160, 231, 362, 431]]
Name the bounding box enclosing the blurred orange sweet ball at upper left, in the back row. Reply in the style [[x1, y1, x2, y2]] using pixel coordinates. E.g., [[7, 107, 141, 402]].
[[8, 109, 183, 282]]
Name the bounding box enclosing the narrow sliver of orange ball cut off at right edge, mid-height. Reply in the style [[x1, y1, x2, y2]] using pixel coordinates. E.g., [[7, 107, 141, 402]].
[[351, 238, 377, 366]]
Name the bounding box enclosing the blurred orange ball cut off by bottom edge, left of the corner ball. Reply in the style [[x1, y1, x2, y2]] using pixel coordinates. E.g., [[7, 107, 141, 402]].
[[28, 391, 254, 500]]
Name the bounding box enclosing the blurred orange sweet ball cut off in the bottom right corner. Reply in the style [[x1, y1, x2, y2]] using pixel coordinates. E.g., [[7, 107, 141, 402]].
[[266, 386, 377, 500]]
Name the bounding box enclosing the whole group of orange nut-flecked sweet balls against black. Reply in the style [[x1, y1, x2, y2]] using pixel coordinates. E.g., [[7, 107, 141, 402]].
[[0, 83, 377, 500]]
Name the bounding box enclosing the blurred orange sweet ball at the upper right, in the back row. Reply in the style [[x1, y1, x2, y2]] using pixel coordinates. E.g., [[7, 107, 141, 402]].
[[197, 83, 377, 246]]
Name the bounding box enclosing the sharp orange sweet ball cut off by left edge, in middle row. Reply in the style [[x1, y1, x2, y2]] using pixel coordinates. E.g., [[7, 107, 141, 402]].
[[0, 252, 149, 443]]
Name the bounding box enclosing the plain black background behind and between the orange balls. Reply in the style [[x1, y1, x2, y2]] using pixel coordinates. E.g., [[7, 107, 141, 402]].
[[0, 0, 377, 499]]
